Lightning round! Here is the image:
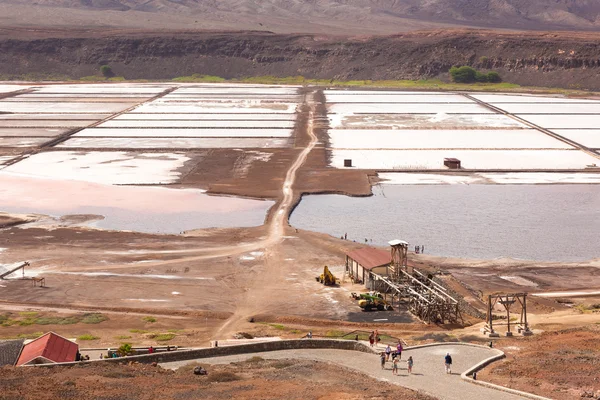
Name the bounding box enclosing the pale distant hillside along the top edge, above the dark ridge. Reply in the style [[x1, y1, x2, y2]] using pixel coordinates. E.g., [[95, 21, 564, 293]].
[[0, 0, 600, 34]]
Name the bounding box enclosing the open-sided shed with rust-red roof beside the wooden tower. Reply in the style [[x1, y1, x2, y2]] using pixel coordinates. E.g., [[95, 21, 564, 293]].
[[346, 247, 392, 288]]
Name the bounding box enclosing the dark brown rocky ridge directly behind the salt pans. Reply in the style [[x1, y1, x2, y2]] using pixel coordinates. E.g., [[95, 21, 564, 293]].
[[0, 31, 600, 89]]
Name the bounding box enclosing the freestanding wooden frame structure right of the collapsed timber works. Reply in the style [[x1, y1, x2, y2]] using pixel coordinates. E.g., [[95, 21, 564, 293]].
[[482, 293, 533, 337]]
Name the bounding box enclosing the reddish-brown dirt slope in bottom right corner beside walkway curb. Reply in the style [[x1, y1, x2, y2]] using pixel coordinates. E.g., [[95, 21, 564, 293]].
[[478, 324, 600, 400]]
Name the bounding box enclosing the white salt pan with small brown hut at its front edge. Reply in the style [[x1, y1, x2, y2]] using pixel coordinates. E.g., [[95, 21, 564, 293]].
[[330, 149, 598, 170]]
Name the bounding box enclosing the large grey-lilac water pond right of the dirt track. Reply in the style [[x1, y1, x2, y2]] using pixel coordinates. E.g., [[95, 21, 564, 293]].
[[290, 185, 600, 261]]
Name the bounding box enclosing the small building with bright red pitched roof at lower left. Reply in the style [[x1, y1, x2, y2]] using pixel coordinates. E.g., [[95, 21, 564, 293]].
[[17, 332, 79, 366]]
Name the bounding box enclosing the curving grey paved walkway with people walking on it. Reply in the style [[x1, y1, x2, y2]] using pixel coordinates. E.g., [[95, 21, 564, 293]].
[[161, 344, 523, 400]]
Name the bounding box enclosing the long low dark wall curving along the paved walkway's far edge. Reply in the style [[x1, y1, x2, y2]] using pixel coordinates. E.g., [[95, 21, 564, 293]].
[[47, 339, 374, 367]]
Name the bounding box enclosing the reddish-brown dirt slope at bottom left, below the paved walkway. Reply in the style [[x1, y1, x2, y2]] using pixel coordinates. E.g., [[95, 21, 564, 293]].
[[0, 357, 433, 400]]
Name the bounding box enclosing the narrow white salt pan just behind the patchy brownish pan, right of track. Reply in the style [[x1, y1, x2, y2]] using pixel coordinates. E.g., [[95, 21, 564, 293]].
[[327, 103, 494, 114]]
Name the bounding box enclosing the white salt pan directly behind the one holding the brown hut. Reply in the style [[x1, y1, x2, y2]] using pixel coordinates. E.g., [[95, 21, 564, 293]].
[[329, 129, 572, 149]]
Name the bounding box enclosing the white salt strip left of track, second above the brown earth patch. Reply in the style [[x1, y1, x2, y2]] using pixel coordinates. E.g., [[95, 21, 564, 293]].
[[73, 128, 292, 138]]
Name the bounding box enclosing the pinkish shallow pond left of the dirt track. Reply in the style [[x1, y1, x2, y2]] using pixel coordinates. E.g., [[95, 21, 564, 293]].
[[0, 173, 273, 234]]
